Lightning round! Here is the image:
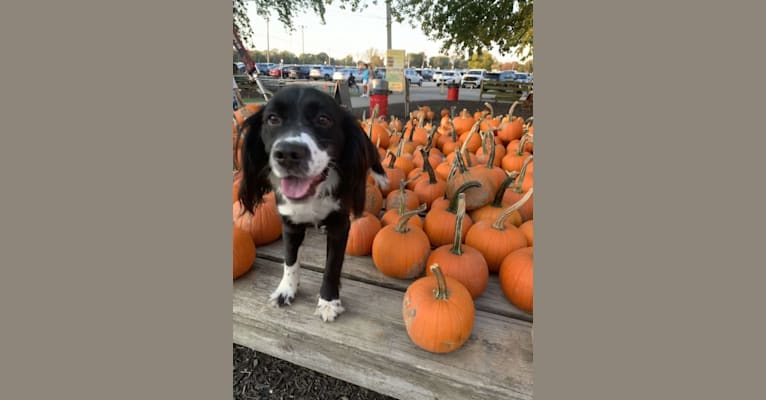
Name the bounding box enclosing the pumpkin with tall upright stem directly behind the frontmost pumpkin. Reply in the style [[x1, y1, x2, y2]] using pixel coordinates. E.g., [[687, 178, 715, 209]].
[[426, 193, 492, 299]]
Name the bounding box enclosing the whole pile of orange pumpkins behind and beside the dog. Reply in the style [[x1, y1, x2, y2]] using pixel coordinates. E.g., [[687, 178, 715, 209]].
[[233, 103, 534, 352]]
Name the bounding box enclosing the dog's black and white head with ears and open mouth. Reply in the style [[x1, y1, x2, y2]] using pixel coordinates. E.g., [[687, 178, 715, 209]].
[[239, 85, 380, 220]]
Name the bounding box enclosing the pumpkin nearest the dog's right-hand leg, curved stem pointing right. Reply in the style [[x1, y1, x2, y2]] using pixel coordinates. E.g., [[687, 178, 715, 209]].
[[372, 206, 431, 279]]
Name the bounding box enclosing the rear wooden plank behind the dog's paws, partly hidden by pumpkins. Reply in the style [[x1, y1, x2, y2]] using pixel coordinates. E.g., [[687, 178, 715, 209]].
[[257, 228, 532, 322]]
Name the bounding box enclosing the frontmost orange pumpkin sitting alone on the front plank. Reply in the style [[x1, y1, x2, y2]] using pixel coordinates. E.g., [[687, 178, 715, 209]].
[[402, 264, 476, 353]]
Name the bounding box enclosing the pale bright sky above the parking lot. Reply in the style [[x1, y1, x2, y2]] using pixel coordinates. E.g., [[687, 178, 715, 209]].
[[247, 2, 518, 62]]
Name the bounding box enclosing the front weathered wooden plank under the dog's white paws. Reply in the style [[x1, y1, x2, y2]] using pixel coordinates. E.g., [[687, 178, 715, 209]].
[[233, 259, 533, 400]]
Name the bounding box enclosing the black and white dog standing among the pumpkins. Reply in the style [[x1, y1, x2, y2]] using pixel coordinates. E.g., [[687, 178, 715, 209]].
[[239, 86, 388, 321]]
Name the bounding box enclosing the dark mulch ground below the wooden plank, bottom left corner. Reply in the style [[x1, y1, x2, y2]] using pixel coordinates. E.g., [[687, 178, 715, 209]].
[[233, 344, 394, 400]]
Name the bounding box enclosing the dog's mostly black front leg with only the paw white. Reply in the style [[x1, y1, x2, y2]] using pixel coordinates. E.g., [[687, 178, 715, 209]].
[[314, 212, 351, 322]]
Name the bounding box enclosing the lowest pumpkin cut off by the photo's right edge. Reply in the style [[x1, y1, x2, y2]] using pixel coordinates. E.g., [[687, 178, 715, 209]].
[[499, 247, 535, 313]]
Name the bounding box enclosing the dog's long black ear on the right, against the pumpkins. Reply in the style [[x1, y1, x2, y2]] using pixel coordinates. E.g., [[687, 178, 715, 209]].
[[340, 110, 383, 216]]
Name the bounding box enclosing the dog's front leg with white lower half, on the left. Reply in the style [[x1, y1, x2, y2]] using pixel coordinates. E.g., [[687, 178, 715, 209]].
[[269, 217, 306, 306]]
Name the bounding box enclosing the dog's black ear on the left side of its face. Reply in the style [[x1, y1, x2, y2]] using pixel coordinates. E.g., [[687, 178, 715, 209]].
[[239, 108, 271, 212]]
